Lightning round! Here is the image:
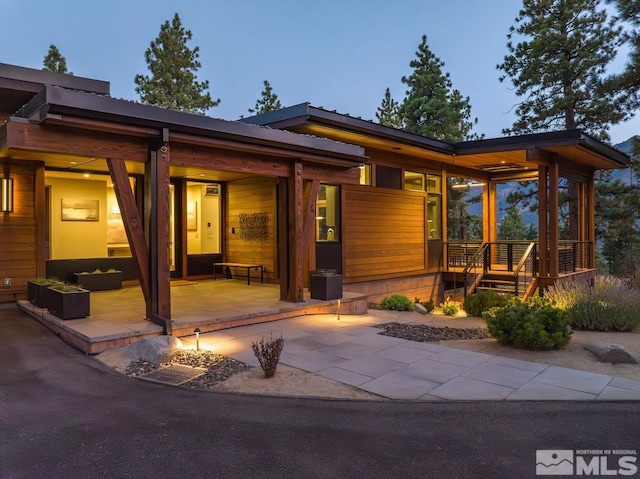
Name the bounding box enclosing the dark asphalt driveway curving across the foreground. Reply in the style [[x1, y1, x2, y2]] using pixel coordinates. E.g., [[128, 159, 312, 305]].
[[0, 306, 640, 479]]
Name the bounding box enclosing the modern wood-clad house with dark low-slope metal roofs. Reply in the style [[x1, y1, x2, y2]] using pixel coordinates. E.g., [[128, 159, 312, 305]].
[[0, 64, 628, 333]]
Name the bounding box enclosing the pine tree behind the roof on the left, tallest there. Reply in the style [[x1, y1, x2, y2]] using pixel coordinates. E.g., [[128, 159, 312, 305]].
[[134, 13, 220, 114]]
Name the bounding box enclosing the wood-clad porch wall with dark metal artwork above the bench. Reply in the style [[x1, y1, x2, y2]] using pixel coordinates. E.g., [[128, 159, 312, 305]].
[[224, 177, 277, 279]]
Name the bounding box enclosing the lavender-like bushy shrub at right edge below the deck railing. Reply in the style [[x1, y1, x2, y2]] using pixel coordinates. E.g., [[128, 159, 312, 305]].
[[545, 276, 640, 331]]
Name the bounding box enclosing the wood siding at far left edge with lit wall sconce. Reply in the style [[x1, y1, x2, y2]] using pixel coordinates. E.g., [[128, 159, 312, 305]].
[[0, 163, 38, 302]]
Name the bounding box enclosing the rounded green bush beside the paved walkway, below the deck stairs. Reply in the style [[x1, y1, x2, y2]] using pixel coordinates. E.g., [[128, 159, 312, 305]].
[[482, 297, 571, 350]]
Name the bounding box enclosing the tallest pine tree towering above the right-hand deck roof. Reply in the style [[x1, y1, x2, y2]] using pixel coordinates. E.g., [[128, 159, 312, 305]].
[[497, 0, 625, 140]]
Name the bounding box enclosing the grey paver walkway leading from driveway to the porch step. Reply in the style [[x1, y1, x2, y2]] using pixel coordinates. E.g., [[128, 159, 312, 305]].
[[182, 315, 640, 401]]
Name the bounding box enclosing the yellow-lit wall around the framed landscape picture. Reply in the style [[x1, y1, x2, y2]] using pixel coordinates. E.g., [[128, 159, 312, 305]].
[[45, 178, 107, 259]]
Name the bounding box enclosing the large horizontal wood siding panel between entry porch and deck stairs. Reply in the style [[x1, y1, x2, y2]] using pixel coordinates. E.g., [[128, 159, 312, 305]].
[[342, 187, 426, 282]]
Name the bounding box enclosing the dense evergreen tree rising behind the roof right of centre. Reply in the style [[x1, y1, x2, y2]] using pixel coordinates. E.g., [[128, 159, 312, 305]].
[[400, 35, 478, 142]]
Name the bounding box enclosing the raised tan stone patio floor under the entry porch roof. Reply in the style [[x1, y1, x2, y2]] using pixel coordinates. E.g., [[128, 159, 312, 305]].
[[17, 279, 367, 354]]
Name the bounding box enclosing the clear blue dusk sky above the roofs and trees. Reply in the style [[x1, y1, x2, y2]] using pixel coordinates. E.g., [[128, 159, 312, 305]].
[[0, 0, 640, 144]]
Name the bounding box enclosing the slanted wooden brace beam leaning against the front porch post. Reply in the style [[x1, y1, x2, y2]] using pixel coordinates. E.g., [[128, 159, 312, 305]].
[[107, 158, 151, 306]]
